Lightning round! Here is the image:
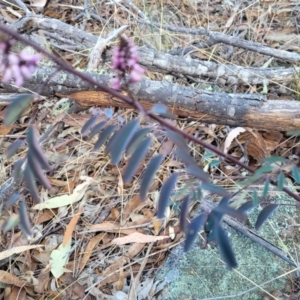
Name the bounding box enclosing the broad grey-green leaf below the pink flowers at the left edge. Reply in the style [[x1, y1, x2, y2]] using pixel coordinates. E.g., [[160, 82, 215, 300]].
[[4, 94, 34, 126]]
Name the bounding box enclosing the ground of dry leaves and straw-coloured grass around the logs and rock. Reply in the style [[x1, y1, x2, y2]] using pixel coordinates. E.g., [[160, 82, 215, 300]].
[[0, 0, 300, 299]]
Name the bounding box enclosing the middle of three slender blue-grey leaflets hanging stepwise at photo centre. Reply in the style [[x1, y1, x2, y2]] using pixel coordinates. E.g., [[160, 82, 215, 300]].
[[140, 154, 164, 201]]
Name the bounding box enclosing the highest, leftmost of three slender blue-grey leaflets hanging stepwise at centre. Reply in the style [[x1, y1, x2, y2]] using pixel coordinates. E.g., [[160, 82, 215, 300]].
[[123, 137, 152, 183]]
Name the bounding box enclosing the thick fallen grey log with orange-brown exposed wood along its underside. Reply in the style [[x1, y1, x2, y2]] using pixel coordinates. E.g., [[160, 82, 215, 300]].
[[1, 68, 300, 131]]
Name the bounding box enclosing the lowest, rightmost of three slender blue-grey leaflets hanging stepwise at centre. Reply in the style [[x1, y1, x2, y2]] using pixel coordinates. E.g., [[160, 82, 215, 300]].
[[157, 173, 178, 219]]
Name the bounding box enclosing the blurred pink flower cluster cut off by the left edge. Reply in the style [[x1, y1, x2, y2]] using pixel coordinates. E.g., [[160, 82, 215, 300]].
[[0, 40, 41, 87]]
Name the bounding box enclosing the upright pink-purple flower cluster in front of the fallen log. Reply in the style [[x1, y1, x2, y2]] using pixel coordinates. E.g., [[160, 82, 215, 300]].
[[112, 37, 145, 89]]
